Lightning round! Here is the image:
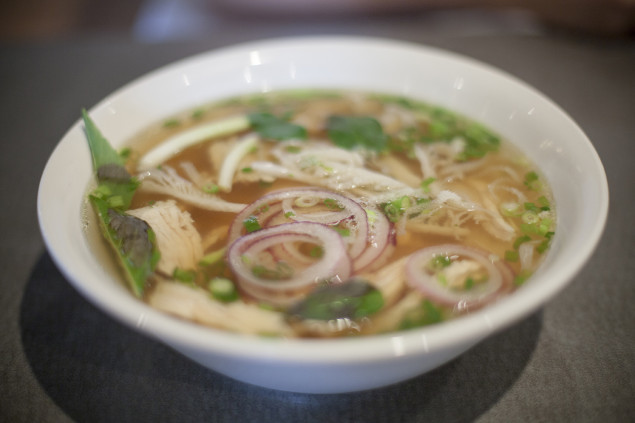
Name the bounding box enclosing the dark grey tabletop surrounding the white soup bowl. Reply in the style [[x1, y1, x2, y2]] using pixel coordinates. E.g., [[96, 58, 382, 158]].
[[0, 16, 635, 423]]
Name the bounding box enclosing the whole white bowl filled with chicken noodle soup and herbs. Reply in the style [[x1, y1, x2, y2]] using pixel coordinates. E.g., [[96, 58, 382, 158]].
[[38, 37, 608, 393]]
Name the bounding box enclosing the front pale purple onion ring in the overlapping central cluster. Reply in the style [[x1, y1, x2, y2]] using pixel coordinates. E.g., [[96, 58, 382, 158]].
[[227, 222, 352, 306]]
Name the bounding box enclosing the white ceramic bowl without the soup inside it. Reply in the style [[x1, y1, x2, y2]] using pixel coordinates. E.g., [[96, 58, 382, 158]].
[[38, 37, 608, 393]]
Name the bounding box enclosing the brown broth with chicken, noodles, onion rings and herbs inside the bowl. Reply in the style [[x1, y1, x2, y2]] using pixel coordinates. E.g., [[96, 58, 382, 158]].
[[84, 91, 555, 337]]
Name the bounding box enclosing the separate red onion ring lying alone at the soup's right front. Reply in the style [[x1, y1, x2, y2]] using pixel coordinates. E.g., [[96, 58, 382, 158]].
[[406, 244, 513, 311]]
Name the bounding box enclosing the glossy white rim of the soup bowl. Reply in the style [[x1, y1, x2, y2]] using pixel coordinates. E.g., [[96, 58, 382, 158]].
[[37, 36, 609, 364]]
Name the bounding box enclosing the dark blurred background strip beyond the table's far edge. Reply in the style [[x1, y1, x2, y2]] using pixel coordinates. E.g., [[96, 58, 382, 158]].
[[0, 0, 635, 42]]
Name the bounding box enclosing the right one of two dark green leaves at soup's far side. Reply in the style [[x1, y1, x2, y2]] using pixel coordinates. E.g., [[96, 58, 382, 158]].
[[326, 116, 389, 151]]
